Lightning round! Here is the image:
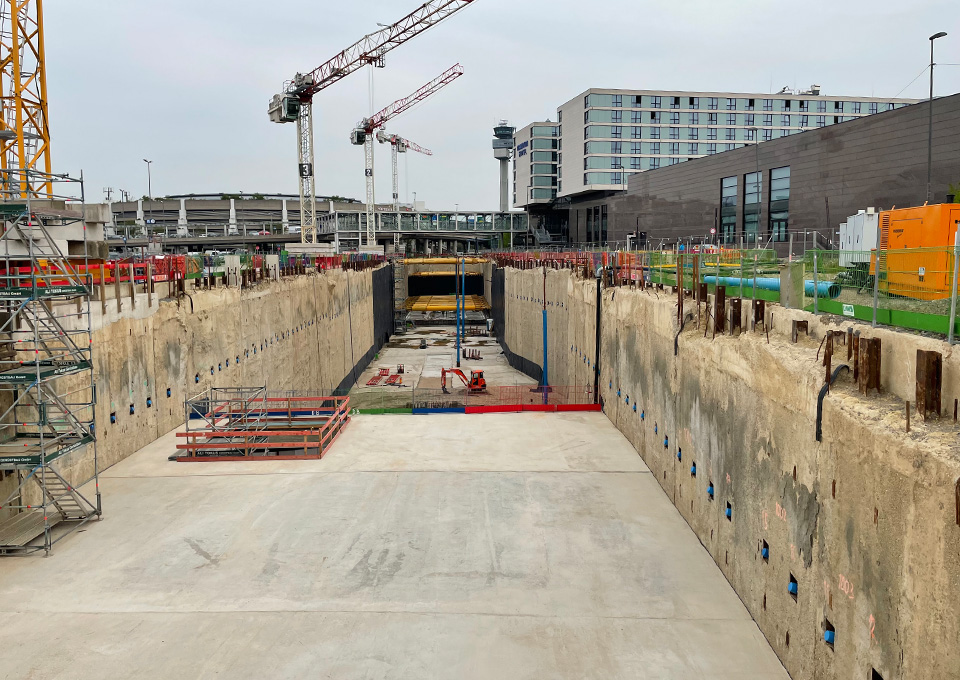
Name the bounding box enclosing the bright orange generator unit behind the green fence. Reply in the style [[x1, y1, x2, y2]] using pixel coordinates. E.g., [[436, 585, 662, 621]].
[[870, 203, 960, 300]]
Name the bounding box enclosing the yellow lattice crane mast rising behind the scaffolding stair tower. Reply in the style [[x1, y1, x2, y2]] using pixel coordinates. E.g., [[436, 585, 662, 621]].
[[0, 0, 52, 199]]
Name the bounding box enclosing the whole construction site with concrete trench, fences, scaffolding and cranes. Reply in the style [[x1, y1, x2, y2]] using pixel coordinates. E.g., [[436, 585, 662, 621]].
[[0, 0, 960, 680]]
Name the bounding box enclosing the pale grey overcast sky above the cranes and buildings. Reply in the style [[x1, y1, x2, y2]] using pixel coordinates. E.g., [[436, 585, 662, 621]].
[[44, 0, 960, 210]]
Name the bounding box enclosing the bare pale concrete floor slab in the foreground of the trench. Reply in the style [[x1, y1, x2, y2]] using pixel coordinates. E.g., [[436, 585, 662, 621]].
[[0, 413, 787, 679]]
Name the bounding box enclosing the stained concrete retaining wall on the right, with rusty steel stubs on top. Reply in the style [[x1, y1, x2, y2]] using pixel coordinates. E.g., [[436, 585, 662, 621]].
[[495, 269, 960, 680]]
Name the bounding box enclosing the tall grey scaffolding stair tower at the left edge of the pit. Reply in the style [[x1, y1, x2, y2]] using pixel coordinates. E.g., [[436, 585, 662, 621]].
[[0, 169, 102, 555]]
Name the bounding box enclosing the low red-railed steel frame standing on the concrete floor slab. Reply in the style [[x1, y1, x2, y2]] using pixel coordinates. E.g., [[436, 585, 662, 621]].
[[177, 397, 350, 462]]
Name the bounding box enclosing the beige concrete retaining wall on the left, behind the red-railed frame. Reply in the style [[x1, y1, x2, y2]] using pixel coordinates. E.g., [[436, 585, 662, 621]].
[[0, 267, 393, 519]]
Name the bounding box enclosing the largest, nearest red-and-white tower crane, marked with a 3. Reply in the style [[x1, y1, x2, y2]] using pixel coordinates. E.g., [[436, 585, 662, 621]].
[[267, 0, 475, 243]]
